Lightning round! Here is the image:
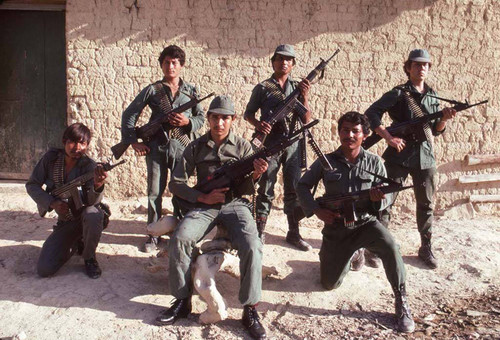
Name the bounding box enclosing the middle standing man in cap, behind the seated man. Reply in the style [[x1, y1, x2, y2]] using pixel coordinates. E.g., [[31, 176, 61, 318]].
[[244, 45, 312, 251]]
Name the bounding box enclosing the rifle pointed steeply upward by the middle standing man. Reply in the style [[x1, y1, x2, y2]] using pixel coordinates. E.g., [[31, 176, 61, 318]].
[[250, 49, 340, 148]]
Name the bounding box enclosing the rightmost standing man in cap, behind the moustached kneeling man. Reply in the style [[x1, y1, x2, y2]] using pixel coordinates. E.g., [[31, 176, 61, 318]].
[[365, 49, 456, 269]]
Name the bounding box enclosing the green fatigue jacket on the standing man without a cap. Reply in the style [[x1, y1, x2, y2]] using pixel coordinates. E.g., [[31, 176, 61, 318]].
[[122, 79, 205, 144]]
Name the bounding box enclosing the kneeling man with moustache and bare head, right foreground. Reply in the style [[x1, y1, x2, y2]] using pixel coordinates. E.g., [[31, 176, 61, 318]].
[[297, 112, 415, 333]]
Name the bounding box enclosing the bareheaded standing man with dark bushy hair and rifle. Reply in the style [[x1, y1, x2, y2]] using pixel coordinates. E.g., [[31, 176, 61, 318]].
[[122, 45, 205, 253]]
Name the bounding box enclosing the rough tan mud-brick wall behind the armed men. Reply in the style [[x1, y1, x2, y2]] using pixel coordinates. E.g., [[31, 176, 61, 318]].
[[66, 0, 500, 215]]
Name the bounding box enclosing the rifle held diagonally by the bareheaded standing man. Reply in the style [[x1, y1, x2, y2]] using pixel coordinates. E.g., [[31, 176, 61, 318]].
[[111, 92, 215, 159]]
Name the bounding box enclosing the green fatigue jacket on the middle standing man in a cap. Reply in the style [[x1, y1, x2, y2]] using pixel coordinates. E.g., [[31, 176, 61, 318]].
[[244, 76, 298, 135]]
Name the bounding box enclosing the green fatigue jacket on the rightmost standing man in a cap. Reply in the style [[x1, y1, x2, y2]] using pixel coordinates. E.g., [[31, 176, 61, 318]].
[[365, 81, 444, 169]]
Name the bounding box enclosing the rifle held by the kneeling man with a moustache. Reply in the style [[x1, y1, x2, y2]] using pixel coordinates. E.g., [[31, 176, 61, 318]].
[[294, 182, 414, 228]]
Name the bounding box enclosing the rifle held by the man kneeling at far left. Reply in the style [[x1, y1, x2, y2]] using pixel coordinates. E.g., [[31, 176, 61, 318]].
[[38, 160, 125, 217]]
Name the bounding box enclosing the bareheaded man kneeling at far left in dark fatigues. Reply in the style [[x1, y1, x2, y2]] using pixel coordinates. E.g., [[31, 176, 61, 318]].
[[26, 123, 107, 279]]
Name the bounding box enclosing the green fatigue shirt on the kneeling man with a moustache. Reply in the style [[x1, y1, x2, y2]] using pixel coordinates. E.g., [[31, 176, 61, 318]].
[[297, 148, 392, 220]]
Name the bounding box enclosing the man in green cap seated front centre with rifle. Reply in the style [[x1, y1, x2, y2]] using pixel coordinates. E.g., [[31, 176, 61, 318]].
[[156, 96, 267, 339]]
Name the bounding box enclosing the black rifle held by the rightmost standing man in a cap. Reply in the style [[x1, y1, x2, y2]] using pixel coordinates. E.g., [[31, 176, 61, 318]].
[[362, 95, 488, 149]]
